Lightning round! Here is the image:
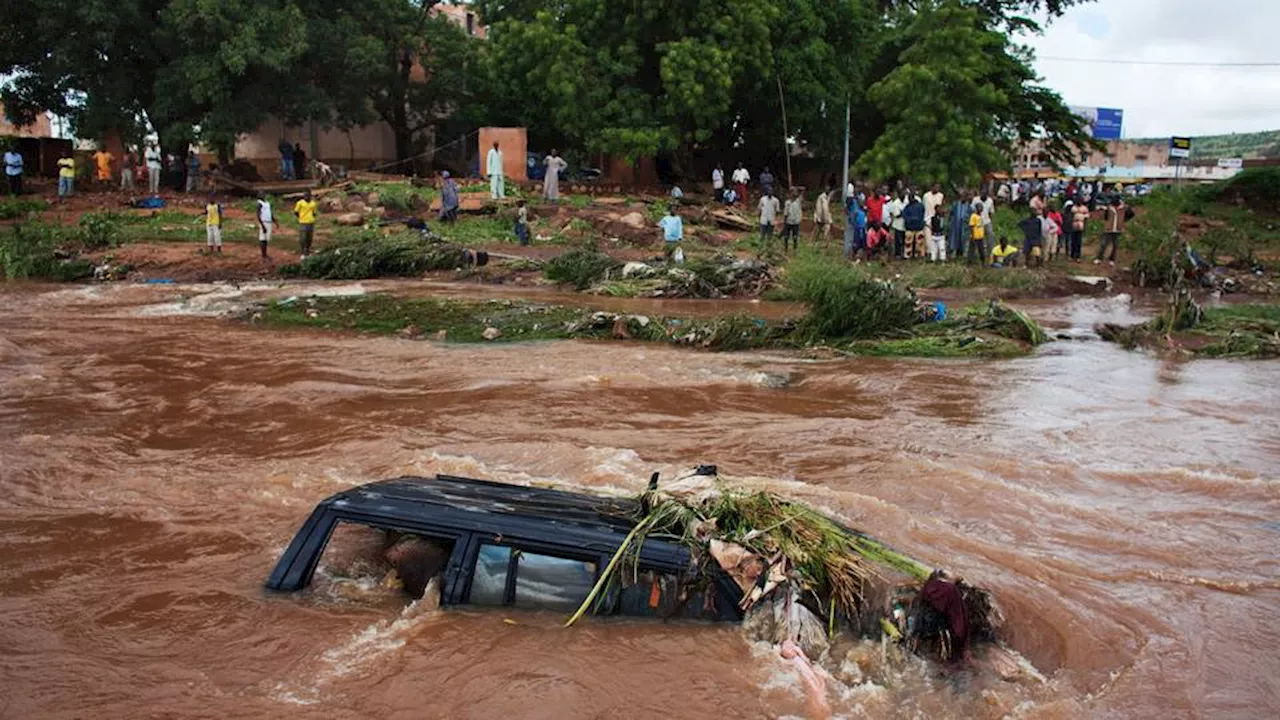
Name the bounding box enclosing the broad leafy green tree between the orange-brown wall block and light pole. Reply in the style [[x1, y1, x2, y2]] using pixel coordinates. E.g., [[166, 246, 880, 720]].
[[477, 0, 876, 172]]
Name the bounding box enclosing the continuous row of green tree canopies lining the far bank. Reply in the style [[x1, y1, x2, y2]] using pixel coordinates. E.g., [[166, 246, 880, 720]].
[[0, 0, 1089, 183]]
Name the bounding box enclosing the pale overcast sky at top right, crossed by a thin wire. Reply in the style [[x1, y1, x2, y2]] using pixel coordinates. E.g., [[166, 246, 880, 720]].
[[1028, 0, 1280, 137]]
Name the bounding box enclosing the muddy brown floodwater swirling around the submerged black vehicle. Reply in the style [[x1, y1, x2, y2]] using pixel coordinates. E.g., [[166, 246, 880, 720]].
[[0, 286, 1280, 719]]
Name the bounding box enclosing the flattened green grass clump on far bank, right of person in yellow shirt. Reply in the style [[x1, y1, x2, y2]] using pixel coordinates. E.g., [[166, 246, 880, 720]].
[[280, 231, 467, 281]]
